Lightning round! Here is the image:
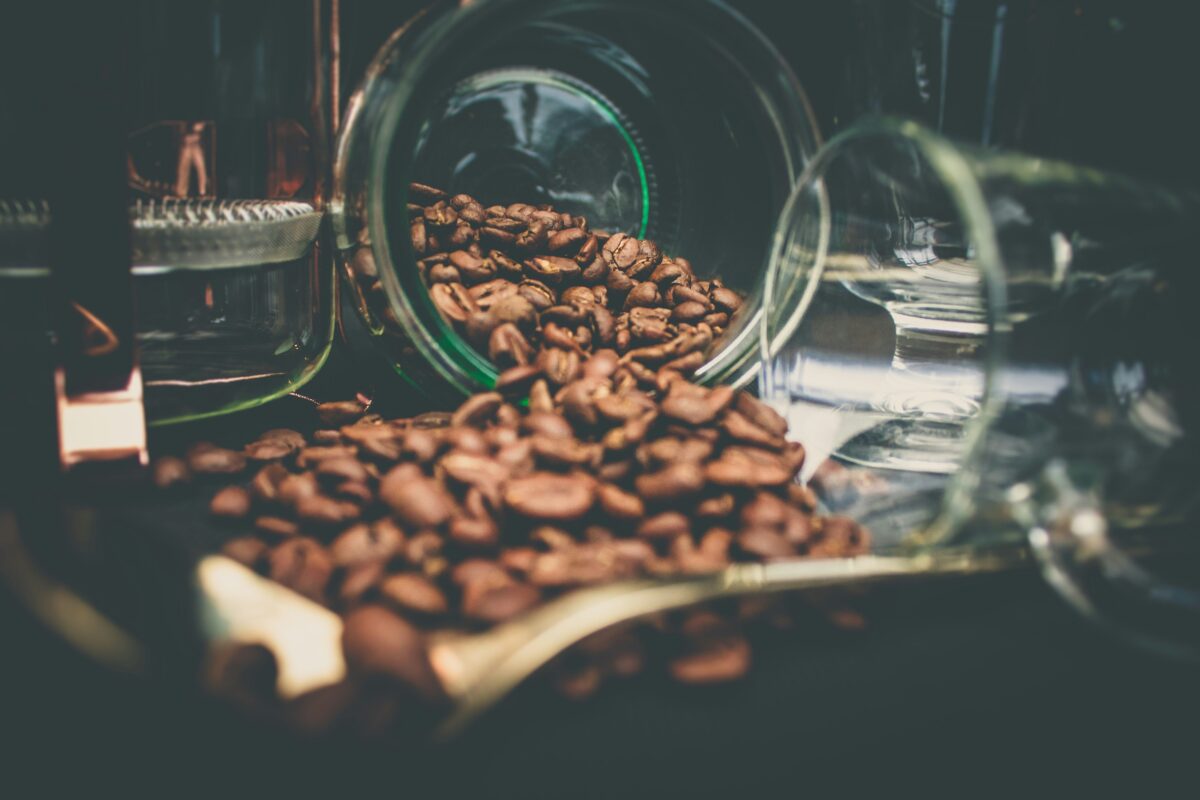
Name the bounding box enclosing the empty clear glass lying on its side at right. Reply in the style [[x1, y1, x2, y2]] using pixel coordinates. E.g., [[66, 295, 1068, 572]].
[[760, 120, 1200, 646]]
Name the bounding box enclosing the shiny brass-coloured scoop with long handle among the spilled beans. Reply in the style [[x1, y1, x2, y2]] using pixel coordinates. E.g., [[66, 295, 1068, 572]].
[[197, 548, 1024, 738]]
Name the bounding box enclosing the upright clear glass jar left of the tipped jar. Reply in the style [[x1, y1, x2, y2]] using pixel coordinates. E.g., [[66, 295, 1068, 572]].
[[0, 0, 334, 425]]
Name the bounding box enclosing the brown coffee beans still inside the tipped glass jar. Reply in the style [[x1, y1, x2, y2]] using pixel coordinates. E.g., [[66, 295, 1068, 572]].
[[352, 184, 743, 386]]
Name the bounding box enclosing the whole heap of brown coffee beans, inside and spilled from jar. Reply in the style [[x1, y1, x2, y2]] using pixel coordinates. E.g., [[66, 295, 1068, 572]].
[[174, 185, 869, 734]]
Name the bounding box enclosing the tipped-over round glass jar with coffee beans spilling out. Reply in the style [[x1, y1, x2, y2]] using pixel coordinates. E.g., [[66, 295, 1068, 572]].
[[330, 0, 818, 396]]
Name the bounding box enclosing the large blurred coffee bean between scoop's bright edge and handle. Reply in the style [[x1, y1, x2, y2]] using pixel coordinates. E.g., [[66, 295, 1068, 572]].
[[342, 606, 443, 698]]
